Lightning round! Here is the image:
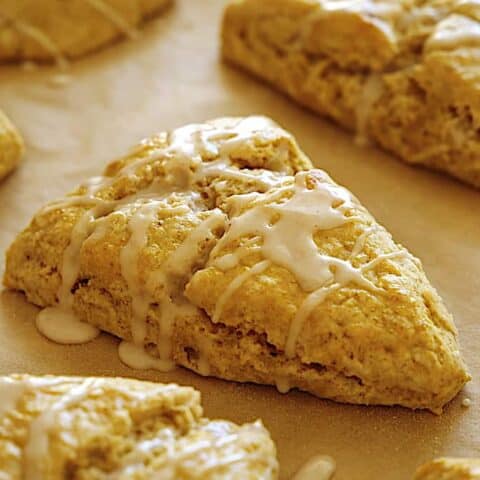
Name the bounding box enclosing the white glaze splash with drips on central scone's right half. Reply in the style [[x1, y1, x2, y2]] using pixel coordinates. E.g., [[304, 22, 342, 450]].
[[210, 170, 405, 366]]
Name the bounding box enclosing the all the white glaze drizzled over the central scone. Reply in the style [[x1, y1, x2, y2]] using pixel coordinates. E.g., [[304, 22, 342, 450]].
[[31, 118, 403, 389]]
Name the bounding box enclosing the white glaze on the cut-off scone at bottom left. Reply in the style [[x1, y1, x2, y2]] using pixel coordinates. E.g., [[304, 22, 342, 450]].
[[0, 376, 277, 480]]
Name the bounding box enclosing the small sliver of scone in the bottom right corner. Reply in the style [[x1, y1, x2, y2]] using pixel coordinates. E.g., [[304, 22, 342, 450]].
[[414, 458, 480, 480]]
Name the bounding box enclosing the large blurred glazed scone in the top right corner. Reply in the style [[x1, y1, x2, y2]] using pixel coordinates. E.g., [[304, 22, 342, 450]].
[[222, 0, 480, 187]]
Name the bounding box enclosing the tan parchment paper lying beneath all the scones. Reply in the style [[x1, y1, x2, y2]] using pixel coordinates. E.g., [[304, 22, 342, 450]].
[[0, 0, 480, 480]]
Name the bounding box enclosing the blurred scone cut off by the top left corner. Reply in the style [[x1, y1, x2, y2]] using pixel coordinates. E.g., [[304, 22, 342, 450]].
[[0, 0, 172, 65]]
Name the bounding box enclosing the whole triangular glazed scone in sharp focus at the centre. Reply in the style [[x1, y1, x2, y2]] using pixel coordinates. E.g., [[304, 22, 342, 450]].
[[4, 117, 469, 412]]
